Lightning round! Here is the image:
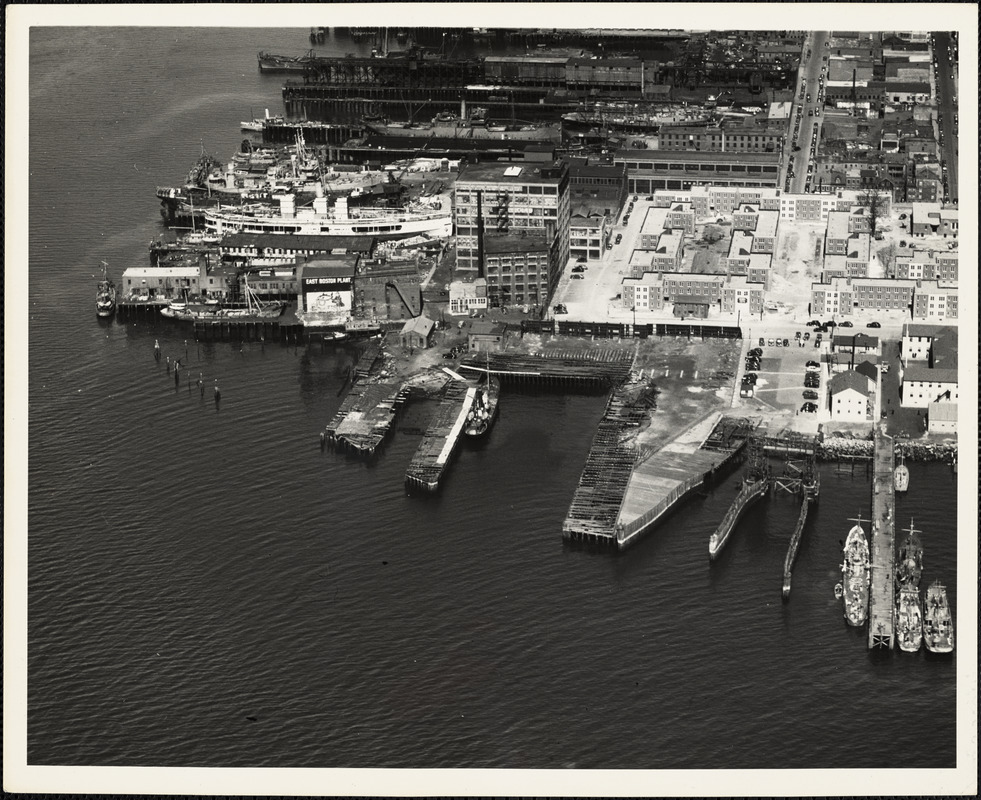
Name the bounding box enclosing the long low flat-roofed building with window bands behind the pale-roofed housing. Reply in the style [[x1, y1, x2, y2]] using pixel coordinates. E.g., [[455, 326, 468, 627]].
[[613, 149, 780, 195]]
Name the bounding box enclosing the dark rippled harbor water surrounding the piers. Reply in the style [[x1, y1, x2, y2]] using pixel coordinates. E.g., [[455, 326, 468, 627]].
[[27, 28, 956, 769]]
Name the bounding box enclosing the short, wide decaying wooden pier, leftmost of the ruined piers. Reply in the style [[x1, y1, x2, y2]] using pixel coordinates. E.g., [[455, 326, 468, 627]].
[[324, 383, 408, 456]]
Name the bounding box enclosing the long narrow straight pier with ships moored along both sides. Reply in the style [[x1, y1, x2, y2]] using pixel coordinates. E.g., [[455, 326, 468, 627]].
[[869, 426, 896, 650]]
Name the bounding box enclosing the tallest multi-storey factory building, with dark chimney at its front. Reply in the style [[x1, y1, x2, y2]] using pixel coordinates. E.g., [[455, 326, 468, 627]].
[[454, 161, 570, 305]]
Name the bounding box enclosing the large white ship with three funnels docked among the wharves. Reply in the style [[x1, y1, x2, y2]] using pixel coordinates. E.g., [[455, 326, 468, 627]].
[[204, 192, 453, 239]]
